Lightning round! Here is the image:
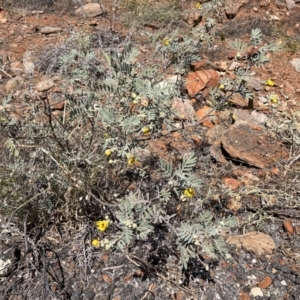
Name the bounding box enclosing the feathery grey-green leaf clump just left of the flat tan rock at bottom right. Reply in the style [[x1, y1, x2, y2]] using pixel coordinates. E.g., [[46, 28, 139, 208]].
[[176, 211, 236, 269]]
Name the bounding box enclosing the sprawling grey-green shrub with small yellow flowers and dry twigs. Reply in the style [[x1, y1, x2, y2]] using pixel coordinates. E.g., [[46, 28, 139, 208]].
[[0, 16, 282, 276]]
